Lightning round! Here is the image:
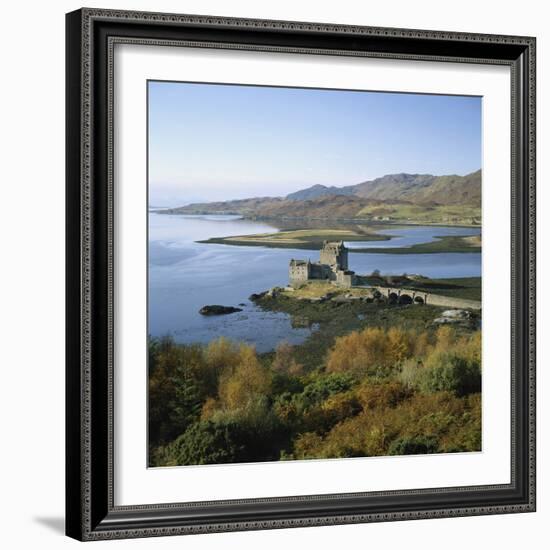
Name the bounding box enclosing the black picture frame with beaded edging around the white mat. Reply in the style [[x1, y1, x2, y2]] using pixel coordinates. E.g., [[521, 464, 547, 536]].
[[66, 9, 535, 540]]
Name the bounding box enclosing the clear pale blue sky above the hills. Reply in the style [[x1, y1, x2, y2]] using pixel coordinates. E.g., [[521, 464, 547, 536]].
[[149, 81, 481, 206]]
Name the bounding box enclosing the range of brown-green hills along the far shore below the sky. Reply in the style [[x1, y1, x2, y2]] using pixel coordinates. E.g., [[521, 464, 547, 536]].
[[164, 170, 481, 224]]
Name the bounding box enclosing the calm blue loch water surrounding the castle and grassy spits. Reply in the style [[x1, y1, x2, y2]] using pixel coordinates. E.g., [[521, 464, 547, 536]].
[[149, 212, 481, 352]]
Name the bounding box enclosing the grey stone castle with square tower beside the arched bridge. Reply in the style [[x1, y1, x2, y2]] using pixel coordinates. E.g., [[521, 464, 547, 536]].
[[288, 241, 355, 288]]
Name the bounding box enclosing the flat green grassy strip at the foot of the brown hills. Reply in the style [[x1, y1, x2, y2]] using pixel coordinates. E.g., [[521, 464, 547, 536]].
[[357, 204, 481, 225]]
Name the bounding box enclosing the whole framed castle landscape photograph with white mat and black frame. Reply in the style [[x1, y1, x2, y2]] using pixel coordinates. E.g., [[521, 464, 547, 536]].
[[66, 9, 535, 540]]
